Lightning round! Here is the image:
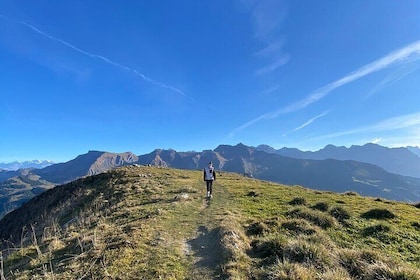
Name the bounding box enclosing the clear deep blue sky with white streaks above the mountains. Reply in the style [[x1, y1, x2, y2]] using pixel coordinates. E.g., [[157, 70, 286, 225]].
[[0, 0, 420, 162]]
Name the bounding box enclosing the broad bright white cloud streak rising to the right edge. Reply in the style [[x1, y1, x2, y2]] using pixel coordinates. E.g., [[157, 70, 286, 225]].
[[229, 41, 420, 136]]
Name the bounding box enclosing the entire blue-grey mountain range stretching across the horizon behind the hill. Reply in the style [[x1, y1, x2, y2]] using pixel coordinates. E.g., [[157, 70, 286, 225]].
[[0, 144, 420, 218]]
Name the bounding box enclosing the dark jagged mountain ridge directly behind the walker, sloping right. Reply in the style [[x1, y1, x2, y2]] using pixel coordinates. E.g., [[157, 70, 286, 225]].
[[139, 144, 420, 201]]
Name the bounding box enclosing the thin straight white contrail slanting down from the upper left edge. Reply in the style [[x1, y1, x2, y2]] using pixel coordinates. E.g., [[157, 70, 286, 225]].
[[0, 14, 187, 97]]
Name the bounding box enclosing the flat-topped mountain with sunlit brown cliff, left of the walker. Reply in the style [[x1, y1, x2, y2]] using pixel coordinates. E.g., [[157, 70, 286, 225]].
[[0, 151, 138, 218]]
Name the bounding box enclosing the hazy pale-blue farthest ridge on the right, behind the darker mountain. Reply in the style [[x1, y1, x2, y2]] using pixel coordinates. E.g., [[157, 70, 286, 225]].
[[264, 143, 420, 178]]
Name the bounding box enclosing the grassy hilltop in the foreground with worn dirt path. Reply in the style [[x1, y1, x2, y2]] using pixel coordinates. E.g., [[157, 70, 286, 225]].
[[0, 166, 420, 280]]
